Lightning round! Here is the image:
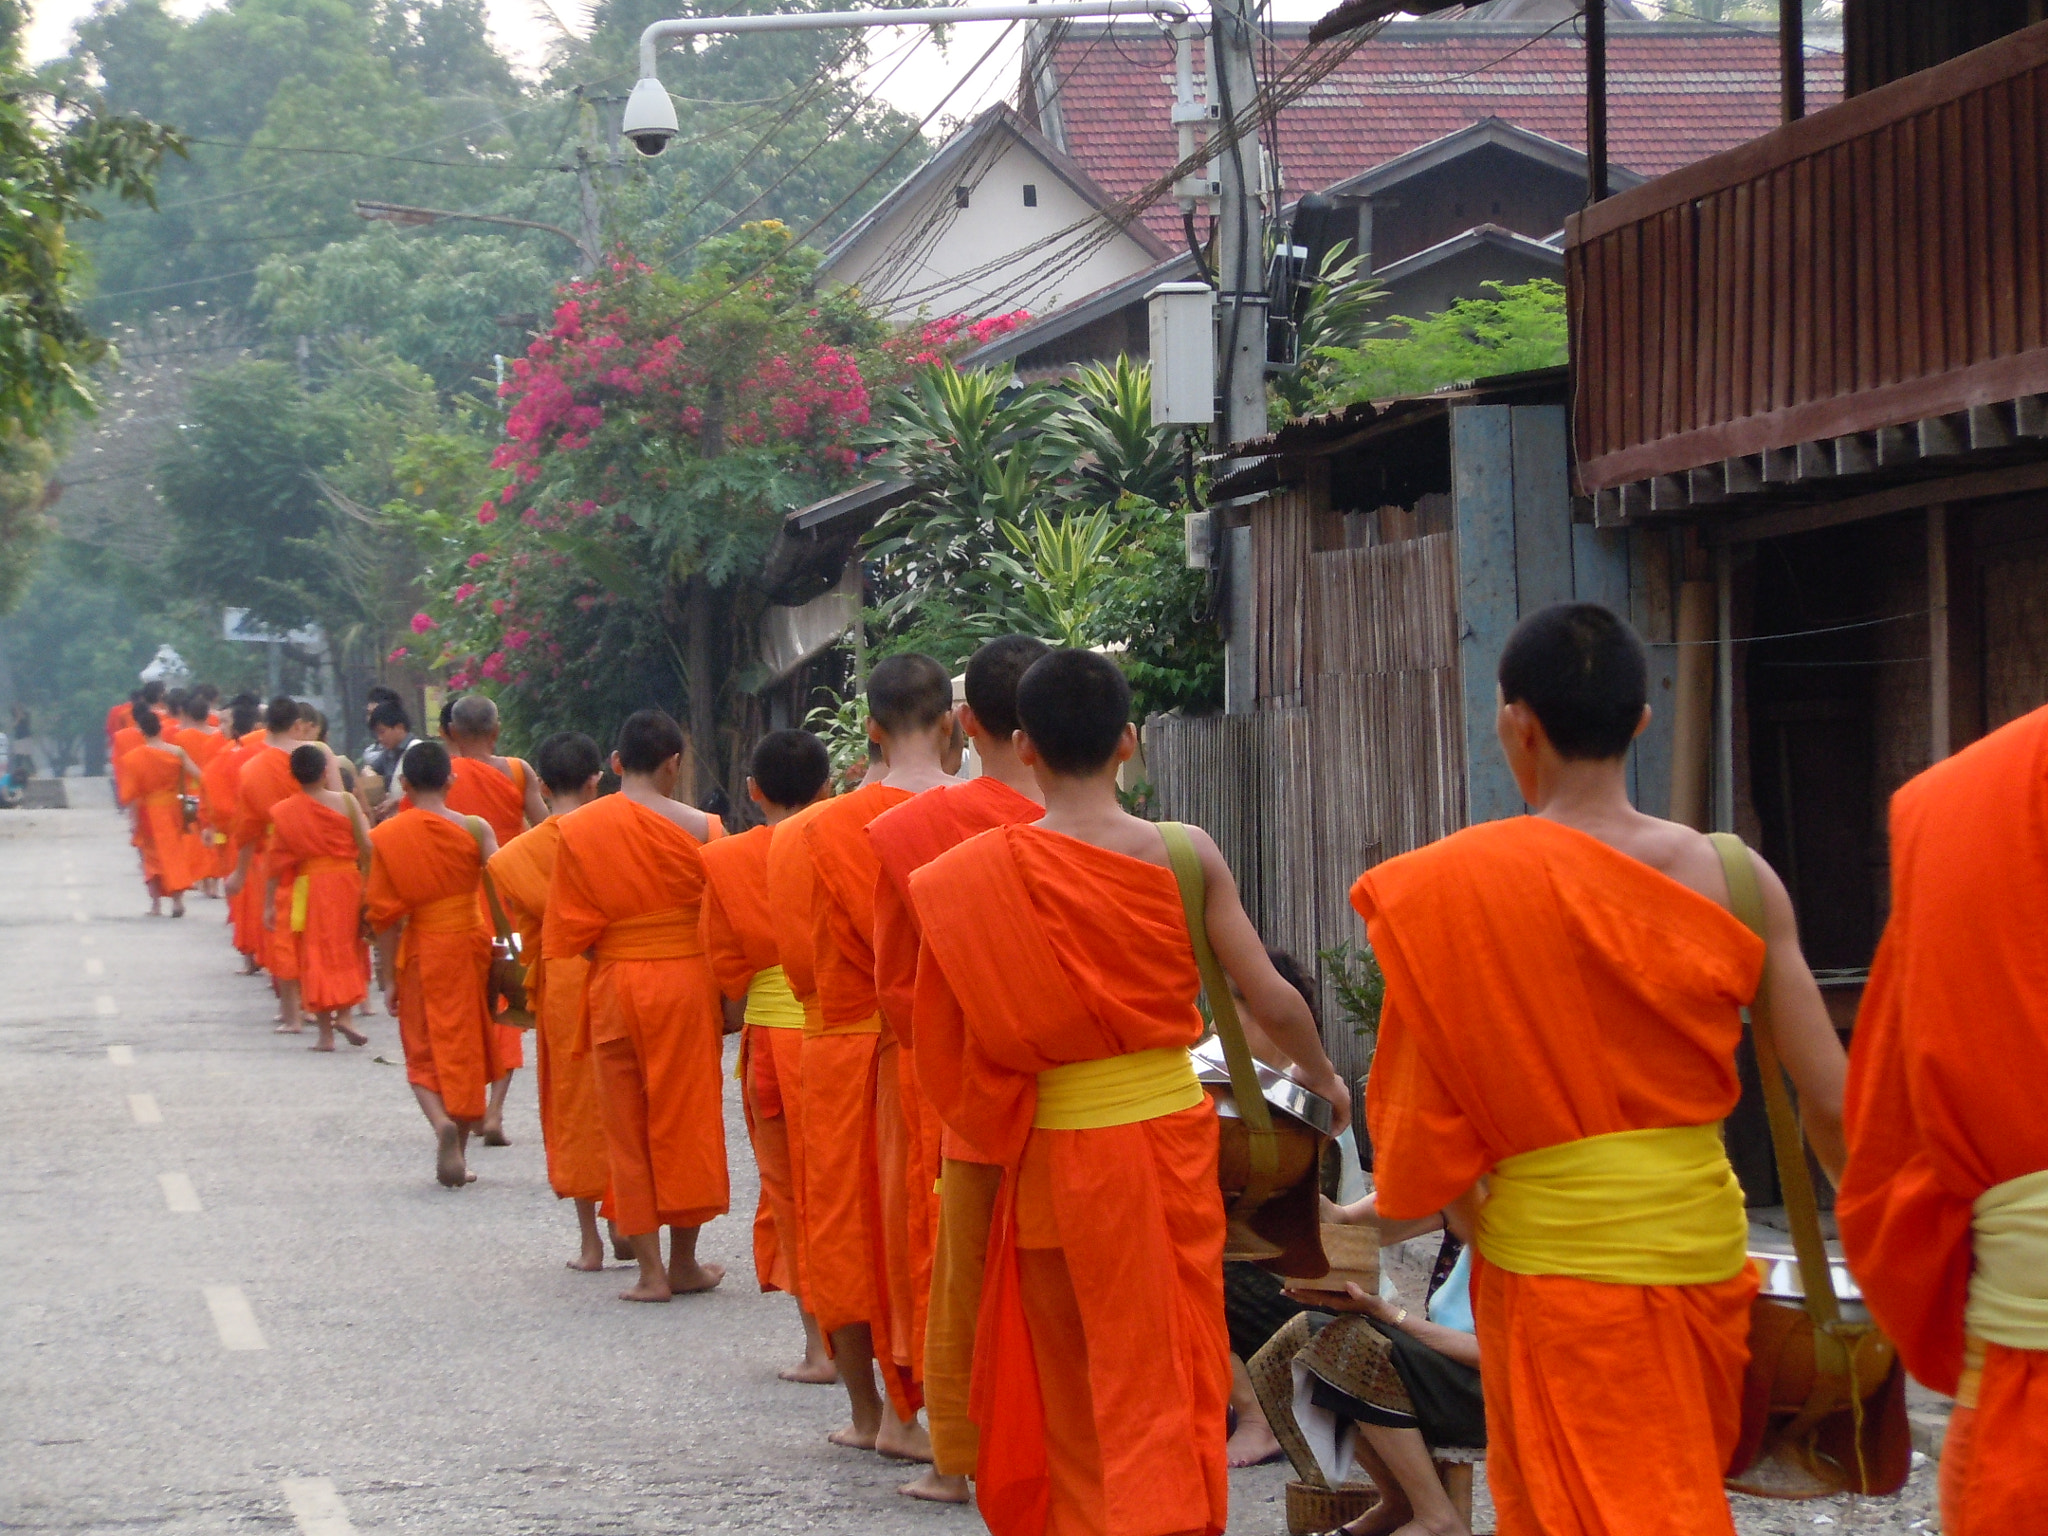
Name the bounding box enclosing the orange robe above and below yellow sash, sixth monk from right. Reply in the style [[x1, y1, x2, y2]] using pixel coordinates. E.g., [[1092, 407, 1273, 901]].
[[702, 827, 803, 1294]]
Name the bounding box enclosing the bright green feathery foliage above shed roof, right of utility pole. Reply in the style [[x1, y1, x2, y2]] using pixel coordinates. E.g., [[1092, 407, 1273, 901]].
[[1313, 279, 1569, 410]]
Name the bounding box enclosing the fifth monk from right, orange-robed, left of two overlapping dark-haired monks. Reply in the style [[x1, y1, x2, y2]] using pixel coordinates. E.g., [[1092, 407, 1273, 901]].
[[799, 653, 958, 1460]]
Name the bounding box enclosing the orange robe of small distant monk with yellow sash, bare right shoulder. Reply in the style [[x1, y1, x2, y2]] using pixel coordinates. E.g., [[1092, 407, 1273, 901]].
[[270, 795, 369, 1014]]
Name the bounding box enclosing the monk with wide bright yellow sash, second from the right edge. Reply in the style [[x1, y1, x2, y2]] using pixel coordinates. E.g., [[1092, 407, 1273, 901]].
[[1352, 604, 1845, 1536]]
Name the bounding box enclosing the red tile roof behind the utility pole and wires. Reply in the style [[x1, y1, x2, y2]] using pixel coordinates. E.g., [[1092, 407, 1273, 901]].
[[1053, 23, 1841, 242]]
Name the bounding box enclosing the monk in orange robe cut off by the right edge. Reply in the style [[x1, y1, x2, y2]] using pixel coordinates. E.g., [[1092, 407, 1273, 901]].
[[1835, 709, 2048, 1536]]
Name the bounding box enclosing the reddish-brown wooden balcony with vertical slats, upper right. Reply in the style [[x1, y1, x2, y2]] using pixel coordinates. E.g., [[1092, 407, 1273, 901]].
[[1565, 23, 2048, 522]]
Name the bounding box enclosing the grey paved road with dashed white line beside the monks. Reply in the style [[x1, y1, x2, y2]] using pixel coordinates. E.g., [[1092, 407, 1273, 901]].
[[0, 794, 1925, 1536]]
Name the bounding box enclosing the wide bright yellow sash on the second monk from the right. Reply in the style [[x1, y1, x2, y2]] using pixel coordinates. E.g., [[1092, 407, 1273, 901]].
[[1479, 1124, 1749, 1286]]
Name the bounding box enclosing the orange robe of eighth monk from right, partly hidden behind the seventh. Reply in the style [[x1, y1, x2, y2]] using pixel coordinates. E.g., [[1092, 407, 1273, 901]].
[[492, 817, 610, 1200]]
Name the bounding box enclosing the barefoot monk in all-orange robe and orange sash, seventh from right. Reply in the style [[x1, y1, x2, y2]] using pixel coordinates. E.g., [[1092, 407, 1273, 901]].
[[541, 709, 731, 1300]]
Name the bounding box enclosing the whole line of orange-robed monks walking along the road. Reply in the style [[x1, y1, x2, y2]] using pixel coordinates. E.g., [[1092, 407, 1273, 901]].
[[117, 604, 2048, 1536]]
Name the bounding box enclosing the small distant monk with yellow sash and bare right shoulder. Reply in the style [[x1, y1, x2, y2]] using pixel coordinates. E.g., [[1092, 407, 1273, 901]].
[[264, 741, 371, 1051]]
